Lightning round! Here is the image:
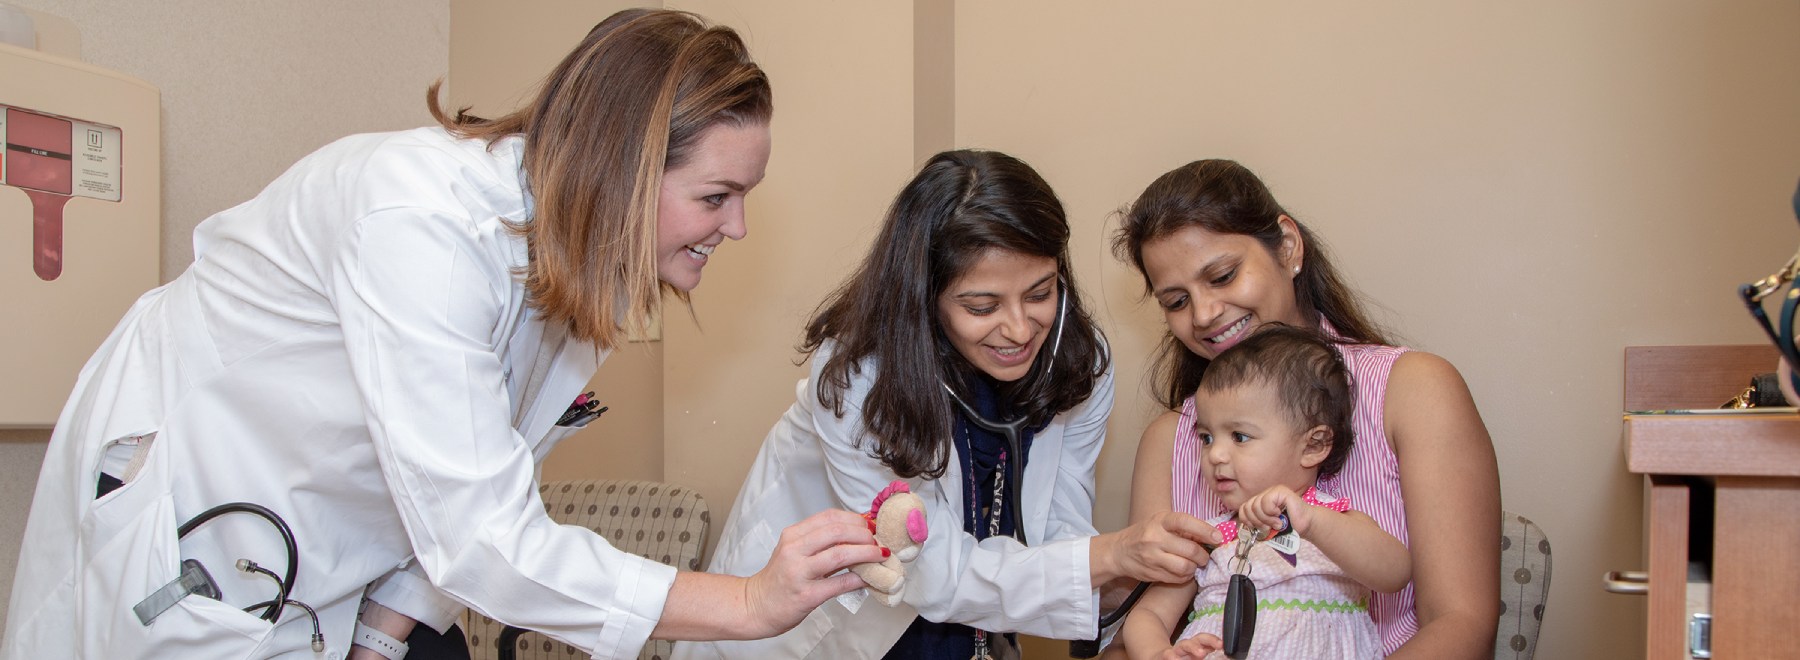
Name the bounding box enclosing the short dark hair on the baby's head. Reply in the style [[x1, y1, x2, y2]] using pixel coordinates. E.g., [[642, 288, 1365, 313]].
[[1199, 326, 1355, 477]]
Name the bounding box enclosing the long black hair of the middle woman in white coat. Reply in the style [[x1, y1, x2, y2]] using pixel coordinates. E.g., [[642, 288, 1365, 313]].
[[801, 149, 1109, 478]]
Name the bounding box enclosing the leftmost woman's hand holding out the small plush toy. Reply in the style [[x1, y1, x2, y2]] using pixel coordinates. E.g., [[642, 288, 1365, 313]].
[[743, 511, 887, 637]]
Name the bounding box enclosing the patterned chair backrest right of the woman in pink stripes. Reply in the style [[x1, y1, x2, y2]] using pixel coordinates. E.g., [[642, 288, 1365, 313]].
[[1494, 511, 1550, 660]]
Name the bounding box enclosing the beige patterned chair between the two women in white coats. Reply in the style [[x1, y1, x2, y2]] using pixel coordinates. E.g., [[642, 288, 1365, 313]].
[[463, 480, 713, 660]]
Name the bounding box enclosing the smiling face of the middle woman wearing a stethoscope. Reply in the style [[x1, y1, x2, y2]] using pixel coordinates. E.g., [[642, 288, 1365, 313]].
[[938, 248, 1058, 381]]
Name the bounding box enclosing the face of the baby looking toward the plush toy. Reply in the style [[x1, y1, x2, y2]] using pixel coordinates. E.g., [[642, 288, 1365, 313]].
[[1193, 381, 1332, 511]]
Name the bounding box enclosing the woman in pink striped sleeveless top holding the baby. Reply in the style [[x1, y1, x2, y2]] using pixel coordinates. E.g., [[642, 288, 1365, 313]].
[[1112, 160, 1499, 658]]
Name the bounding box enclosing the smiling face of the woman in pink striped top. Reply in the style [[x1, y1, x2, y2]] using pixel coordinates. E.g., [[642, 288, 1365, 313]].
[[1143, 216, 1312, 360]]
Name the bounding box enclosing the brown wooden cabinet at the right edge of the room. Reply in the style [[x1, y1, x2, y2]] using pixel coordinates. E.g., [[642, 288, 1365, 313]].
[[1624, 345, 1800, 660]]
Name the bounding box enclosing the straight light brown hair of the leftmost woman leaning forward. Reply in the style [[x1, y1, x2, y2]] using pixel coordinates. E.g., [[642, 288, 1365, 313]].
[[427, 9, 774, 349]]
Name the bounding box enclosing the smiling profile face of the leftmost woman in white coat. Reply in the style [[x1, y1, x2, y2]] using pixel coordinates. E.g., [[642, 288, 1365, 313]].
[[657, 124, 769, 291]]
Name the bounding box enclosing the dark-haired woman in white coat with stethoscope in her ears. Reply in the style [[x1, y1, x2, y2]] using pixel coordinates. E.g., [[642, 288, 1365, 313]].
[[675, 151, 1217, 660]]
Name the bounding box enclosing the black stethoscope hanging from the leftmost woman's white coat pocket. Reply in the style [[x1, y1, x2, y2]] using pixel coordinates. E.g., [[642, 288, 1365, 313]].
[[131, 502, 326, 653]]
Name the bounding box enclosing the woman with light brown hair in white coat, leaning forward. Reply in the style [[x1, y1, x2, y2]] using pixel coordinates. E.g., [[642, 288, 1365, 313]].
[[0, 9, 880, 658]]
